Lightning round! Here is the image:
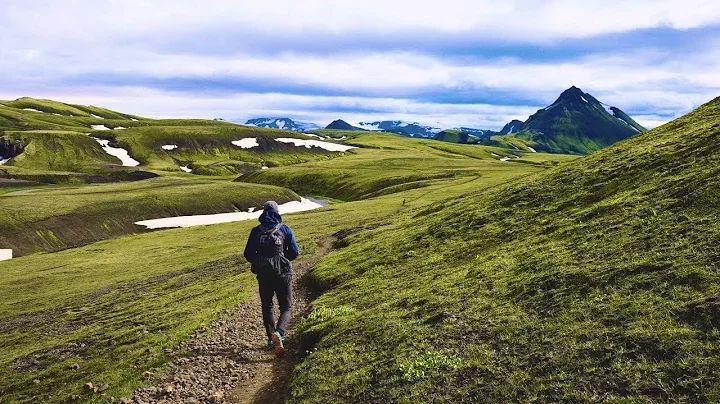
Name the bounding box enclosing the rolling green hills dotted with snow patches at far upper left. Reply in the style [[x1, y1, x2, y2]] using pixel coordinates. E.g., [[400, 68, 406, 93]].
[[0, 98, 358, 178]]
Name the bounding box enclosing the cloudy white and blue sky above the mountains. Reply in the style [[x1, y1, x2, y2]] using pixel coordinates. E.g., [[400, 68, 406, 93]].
[[0, 0, 720, 130]]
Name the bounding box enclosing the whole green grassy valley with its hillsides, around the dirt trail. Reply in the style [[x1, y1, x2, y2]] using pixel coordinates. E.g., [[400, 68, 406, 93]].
[[0, 93, 720, 403]]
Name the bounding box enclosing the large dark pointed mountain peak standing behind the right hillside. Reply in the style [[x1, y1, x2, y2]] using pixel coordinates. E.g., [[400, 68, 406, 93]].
[[512, 86, 646, 154]]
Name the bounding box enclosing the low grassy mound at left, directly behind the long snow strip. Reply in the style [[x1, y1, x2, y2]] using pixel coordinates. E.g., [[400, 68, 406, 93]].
[[0, 177, 299, 256]]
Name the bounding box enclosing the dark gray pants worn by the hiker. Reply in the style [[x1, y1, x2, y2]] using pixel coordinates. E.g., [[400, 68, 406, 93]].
[[258, 274, 292, 339]]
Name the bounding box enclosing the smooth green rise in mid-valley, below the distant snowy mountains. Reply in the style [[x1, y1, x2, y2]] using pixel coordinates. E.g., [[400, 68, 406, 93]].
[[239, 131, 568, 200]]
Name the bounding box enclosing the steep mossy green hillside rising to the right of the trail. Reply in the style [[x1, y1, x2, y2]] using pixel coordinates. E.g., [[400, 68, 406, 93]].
[[291, 99, 720, 402]]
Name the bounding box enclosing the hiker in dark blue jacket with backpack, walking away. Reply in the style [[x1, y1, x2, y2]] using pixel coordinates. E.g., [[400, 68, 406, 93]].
[[243, 201, 300, 357]]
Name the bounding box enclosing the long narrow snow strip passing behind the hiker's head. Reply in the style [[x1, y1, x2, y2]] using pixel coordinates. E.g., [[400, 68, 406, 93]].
[[135, 198, 328, 229]]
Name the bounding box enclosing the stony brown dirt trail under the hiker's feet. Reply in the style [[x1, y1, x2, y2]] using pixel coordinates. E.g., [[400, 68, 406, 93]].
[[124, 237, 335, 404]]
